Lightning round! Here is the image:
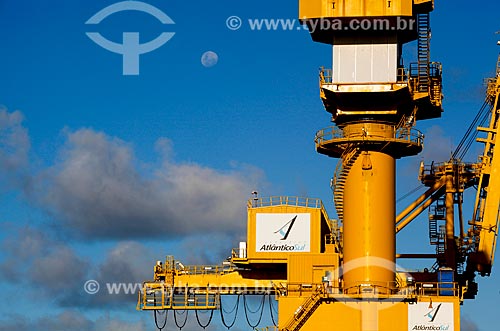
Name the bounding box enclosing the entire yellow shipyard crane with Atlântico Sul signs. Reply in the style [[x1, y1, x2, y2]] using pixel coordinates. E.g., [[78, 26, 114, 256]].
[[137, 0, 500, 331]]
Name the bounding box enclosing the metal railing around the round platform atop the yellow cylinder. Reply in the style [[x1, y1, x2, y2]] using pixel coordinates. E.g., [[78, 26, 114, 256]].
[[315, 126, 424, 145]]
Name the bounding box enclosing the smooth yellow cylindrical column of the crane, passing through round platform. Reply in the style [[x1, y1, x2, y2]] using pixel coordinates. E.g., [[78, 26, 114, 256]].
[[343, 124, 395, 292]]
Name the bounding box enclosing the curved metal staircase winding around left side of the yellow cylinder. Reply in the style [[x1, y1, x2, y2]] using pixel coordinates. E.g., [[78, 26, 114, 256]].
[[332, 148, 360, 221]]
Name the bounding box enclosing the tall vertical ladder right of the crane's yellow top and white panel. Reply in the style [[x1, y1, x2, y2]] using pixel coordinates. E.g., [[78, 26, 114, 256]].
[[417, 13, 431, 92]]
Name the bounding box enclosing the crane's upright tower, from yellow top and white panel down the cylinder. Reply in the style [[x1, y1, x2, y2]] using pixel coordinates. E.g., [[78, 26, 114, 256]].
[[306, 0, 442, 294]]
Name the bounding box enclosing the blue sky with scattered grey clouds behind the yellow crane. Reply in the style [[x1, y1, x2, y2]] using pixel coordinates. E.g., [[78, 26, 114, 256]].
[[0, 0, 500, 331]]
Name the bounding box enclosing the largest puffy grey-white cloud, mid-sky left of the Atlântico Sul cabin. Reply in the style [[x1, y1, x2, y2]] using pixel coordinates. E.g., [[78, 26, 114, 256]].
[[39, 129, 262, 239]]
